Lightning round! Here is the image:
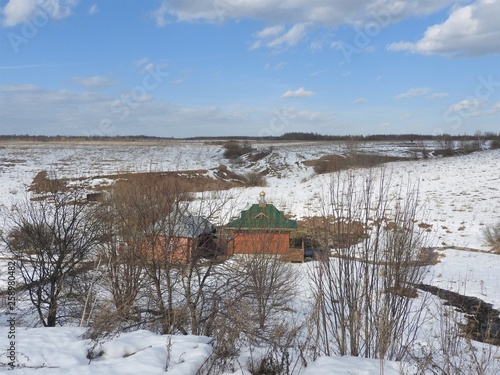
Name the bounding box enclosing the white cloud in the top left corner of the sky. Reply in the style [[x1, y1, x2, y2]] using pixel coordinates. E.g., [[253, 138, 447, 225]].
[[0, 0, 77, 27]]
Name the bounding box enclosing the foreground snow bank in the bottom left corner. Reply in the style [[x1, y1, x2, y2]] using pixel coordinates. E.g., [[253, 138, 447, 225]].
[[0, 327, 212, 375]]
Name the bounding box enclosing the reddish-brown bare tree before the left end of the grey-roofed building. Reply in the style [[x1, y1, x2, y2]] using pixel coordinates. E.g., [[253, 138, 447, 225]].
[[98, 173, 188, 333]]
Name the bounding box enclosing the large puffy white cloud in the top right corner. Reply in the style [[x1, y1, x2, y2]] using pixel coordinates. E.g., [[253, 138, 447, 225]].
[[387, 0, 500, 56]]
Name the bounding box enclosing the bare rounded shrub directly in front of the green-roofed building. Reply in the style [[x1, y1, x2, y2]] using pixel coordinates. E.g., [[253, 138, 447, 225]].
[[205, 244, 302, 374]]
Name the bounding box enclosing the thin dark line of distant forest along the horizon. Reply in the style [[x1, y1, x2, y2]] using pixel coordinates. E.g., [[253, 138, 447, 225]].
[[0, 132, 500, 142]]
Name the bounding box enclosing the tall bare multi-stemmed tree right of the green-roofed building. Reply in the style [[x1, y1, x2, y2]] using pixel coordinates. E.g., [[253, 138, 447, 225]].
[[311, 169, 425, 360]]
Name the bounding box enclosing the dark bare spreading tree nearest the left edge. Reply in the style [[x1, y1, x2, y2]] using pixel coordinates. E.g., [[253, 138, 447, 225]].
[[1, 189, 103, 327]]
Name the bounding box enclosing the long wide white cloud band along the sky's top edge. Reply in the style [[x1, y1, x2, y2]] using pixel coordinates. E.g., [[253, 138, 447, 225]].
[[153, 0, 460, 27]]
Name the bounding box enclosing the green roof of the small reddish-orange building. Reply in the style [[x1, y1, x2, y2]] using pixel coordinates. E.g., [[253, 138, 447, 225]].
[[226, 203, 297, 231]]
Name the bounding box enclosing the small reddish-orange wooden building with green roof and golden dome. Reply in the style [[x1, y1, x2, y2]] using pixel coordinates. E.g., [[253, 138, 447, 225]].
[[226, 192, 298, 260]]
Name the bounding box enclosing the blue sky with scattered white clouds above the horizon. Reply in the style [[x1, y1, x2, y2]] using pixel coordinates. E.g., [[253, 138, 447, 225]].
[[0, 0, 500, 137]]
